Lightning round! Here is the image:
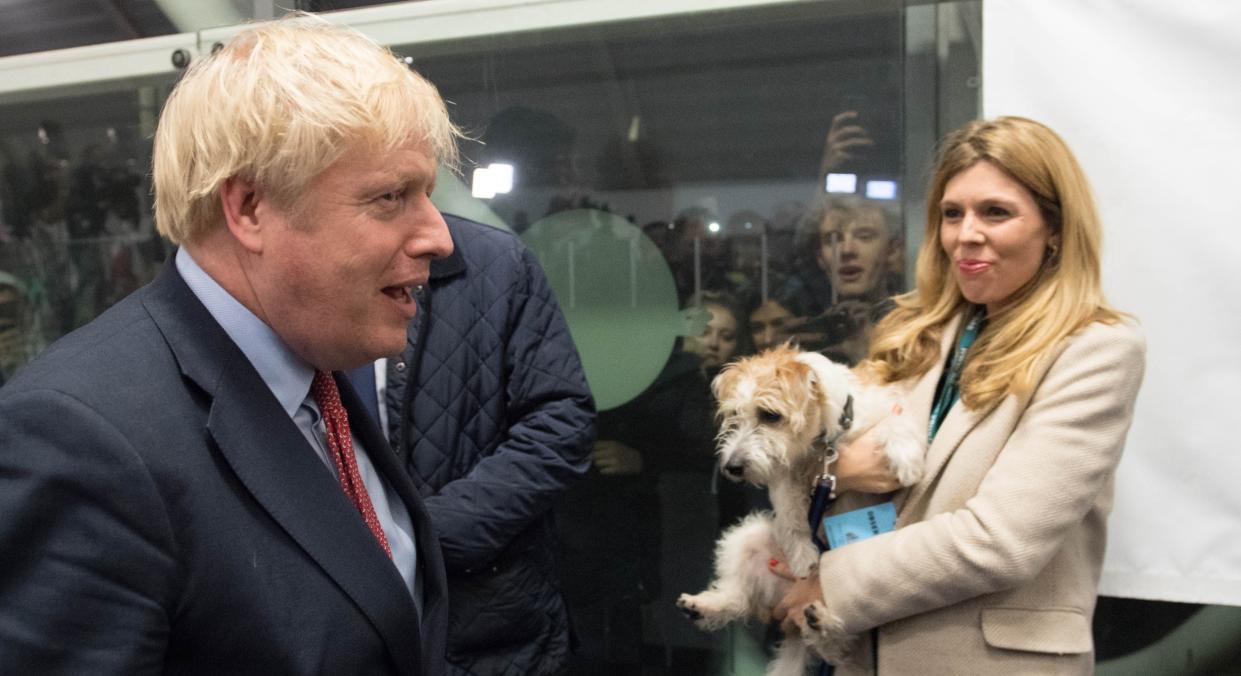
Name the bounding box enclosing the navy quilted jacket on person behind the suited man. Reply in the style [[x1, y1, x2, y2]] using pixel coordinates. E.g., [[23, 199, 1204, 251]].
[[386, 215, 594, 676]]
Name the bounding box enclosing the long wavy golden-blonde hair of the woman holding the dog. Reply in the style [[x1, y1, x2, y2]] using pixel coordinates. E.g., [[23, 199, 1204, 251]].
[[865, 117, 1121, 409]]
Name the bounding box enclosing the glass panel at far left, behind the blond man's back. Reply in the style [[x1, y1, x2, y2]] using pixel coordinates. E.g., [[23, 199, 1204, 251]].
[[0, 76, 171, 378]]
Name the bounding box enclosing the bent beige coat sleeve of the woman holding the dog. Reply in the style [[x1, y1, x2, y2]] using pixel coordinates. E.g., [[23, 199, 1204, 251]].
[[819, 324, 1145, 633]]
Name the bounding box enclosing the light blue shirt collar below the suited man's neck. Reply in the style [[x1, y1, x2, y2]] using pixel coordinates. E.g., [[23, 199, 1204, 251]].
[[176, 248, 314, 418]]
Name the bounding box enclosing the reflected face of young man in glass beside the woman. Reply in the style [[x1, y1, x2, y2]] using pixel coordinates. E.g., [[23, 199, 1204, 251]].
[[815, 212, 892, 299]]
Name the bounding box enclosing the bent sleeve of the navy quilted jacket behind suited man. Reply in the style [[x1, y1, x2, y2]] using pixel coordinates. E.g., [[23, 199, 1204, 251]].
[[414, 224, 594, 572]]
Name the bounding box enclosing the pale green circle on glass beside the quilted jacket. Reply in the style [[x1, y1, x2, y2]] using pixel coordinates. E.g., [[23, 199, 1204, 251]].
[[521, 208, 686, 411]]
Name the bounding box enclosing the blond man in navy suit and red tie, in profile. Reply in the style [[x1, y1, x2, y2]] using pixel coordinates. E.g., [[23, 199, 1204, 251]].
[[0, 16, 458, 676]]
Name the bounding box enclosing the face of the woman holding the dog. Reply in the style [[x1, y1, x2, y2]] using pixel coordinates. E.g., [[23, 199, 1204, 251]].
[[939, 160, 1054, 315]]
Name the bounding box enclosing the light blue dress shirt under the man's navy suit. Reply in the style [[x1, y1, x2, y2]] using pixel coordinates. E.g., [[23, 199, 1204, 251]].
[[176, 248, 422, 614]]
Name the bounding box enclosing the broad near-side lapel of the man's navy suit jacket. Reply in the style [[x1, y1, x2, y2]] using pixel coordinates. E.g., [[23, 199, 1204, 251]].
[[144, 263, 426, 676]]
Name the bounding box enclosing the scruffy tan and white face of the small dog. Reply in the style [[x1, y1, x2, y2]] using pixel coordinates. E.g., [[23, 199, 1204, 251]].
[[711, 345, 825, 486]]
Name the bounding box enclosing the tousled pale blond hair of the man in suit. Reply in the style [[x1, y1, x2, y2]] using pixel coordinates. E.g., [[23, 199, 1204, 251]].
[[153, 12, 460, 244]]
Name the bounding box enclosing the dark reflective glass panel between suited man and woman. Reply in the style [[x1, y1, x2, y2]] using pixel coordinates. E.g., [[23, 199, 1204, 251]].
[[392, 2, 978, 674]]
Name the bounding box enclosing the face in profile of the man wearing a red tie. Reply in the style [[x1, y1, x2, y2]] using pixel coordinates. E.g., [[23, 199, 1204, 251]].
[[251, 143, 453, 370]]
